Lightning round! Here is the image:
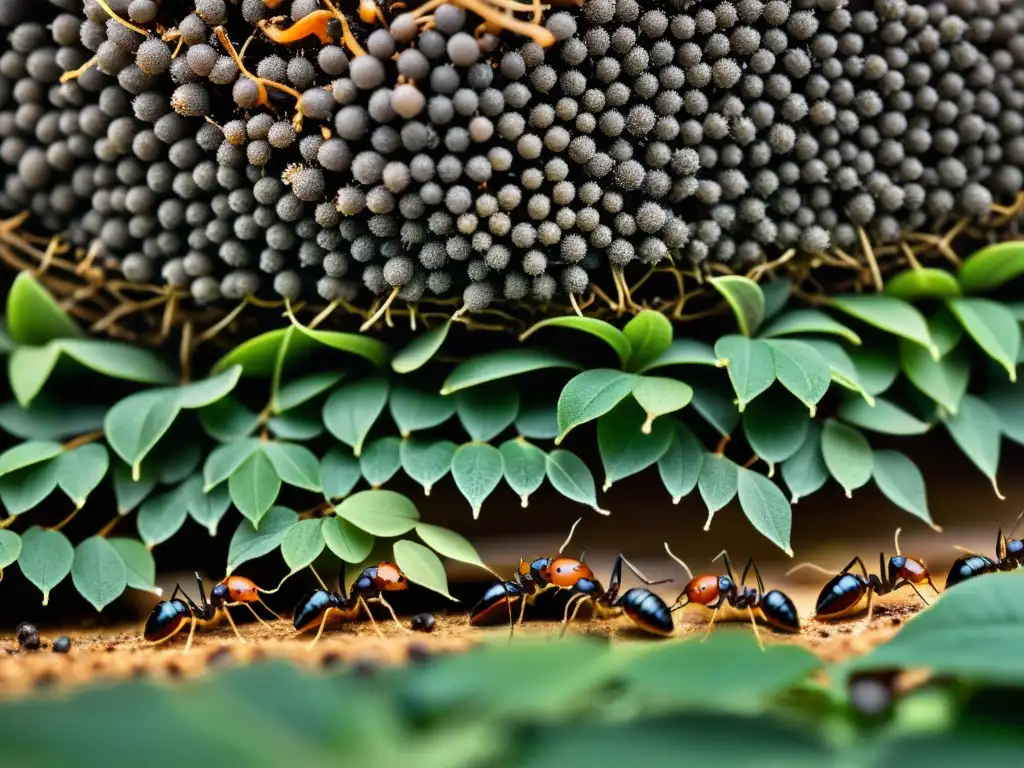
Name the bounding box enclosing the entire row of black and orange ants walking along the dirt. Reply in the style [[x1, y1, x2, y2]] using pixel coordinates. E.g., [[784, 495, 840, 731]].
[[143, 512, 1024, 650]]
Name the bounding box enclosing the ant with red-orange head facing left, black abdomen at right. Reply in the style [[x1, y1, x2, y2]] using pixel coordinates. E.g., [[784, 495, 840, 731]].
[[665, 542, 800, 650]]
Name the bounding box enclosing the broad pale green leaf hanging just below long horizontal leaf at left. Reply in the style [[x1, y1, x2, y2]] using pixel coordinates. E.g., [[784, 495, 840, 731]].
[[103, 389, 181, 480]]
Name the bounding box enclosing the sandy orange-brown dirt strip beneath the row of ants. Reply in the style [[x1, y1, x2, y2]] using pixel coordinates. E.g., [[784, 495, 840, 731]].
[[0, 589, 921, 696]]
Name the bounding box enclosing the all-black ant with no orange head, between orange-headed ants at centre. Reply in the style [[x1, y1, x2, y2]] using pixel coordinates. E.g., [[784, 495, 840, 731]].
[[561, 553, 675, 637]]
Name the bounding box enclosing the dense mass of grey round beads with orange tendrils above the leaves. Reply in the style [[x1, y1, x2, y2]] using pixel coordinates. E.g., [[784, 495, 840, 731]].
[[0, 0, 1024, 310]]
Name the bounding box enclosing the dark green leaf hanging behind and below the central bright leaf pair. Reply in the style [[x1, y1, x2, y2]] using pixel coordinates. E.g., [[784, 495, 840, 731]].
[[597, 400, 673, 490]]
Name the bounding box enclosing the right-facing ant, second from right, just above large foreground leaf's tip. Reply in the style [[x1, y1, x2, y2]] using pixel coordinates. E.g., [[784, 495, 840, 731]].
[[786, 528, 939, 624]]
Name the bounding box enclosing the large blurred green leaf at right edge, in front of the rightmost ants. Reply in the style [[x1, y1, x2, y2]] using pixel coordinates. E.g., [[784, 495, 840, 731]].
[[848, 571, 1024, 686]]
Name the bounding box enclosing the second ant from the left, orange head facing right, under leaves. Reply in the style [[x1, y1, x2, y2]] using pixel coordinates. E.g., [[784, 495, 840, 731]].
[[292, 560, 410, 645]]
